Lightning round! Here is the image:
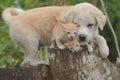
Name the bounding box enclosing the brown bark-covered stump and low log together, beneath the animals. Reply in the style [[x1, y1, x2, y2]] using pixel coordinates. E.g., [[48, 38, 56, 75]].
[[0, 48, 120, 80]]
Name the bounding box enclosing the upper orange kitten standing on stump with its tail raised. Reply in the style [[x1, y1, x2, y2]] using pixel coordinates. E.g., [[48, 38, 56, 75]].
[[51, 16, 77, 49]]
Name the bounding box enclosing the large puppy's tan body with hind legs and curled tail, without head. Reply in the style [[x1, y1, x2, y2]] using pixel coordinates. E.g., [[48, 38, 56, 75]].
[[2, 7, 68, 66]]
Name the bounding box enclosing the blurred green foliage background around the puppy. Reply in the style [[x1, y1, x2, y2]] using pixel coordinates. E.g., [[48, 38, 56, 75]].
[[0, 0, 120, 68]]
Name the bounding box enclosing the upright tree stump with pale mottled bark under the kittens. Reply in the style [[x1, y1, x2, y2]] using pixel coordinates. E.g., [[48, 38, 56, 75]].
[[48, 48, 120, 80]]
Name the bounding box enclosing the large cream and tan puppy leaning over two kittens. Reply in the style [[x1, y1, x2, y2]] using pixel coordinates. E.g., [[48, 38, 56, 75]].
[[2, 3, 109, 65]]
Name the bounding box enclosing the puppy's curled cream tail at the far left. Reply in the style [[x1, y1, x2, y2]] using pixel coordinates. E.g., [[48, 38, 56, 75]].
[[2, 8, 23, 25]]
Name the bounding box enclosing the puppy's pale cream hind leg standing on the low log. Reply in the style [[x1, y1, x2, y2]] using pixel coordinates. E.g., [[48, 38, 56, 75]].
[[23, 36, 44, 66]]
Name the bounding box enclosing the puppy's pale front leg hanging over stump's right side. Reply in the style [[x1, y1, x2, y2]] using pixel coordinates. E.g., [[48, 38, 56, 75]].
[[95, 34, 109, 58]]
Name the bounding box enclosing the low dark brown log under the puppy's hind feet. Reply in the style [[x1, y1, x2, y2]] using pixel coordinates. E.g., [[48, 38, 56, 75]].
[[0, 65, 53, 80]]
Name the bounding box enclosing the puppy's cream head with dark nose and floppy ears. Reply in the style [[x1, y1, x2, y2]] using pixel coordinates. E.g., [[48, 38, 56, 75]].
[[65, 3, 106, 42]]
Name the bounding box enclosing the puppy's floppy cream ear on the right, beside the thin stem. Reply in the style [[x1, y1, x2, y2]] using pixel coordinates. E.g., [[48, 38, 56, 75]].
[[95, 11, 106, 30]]
